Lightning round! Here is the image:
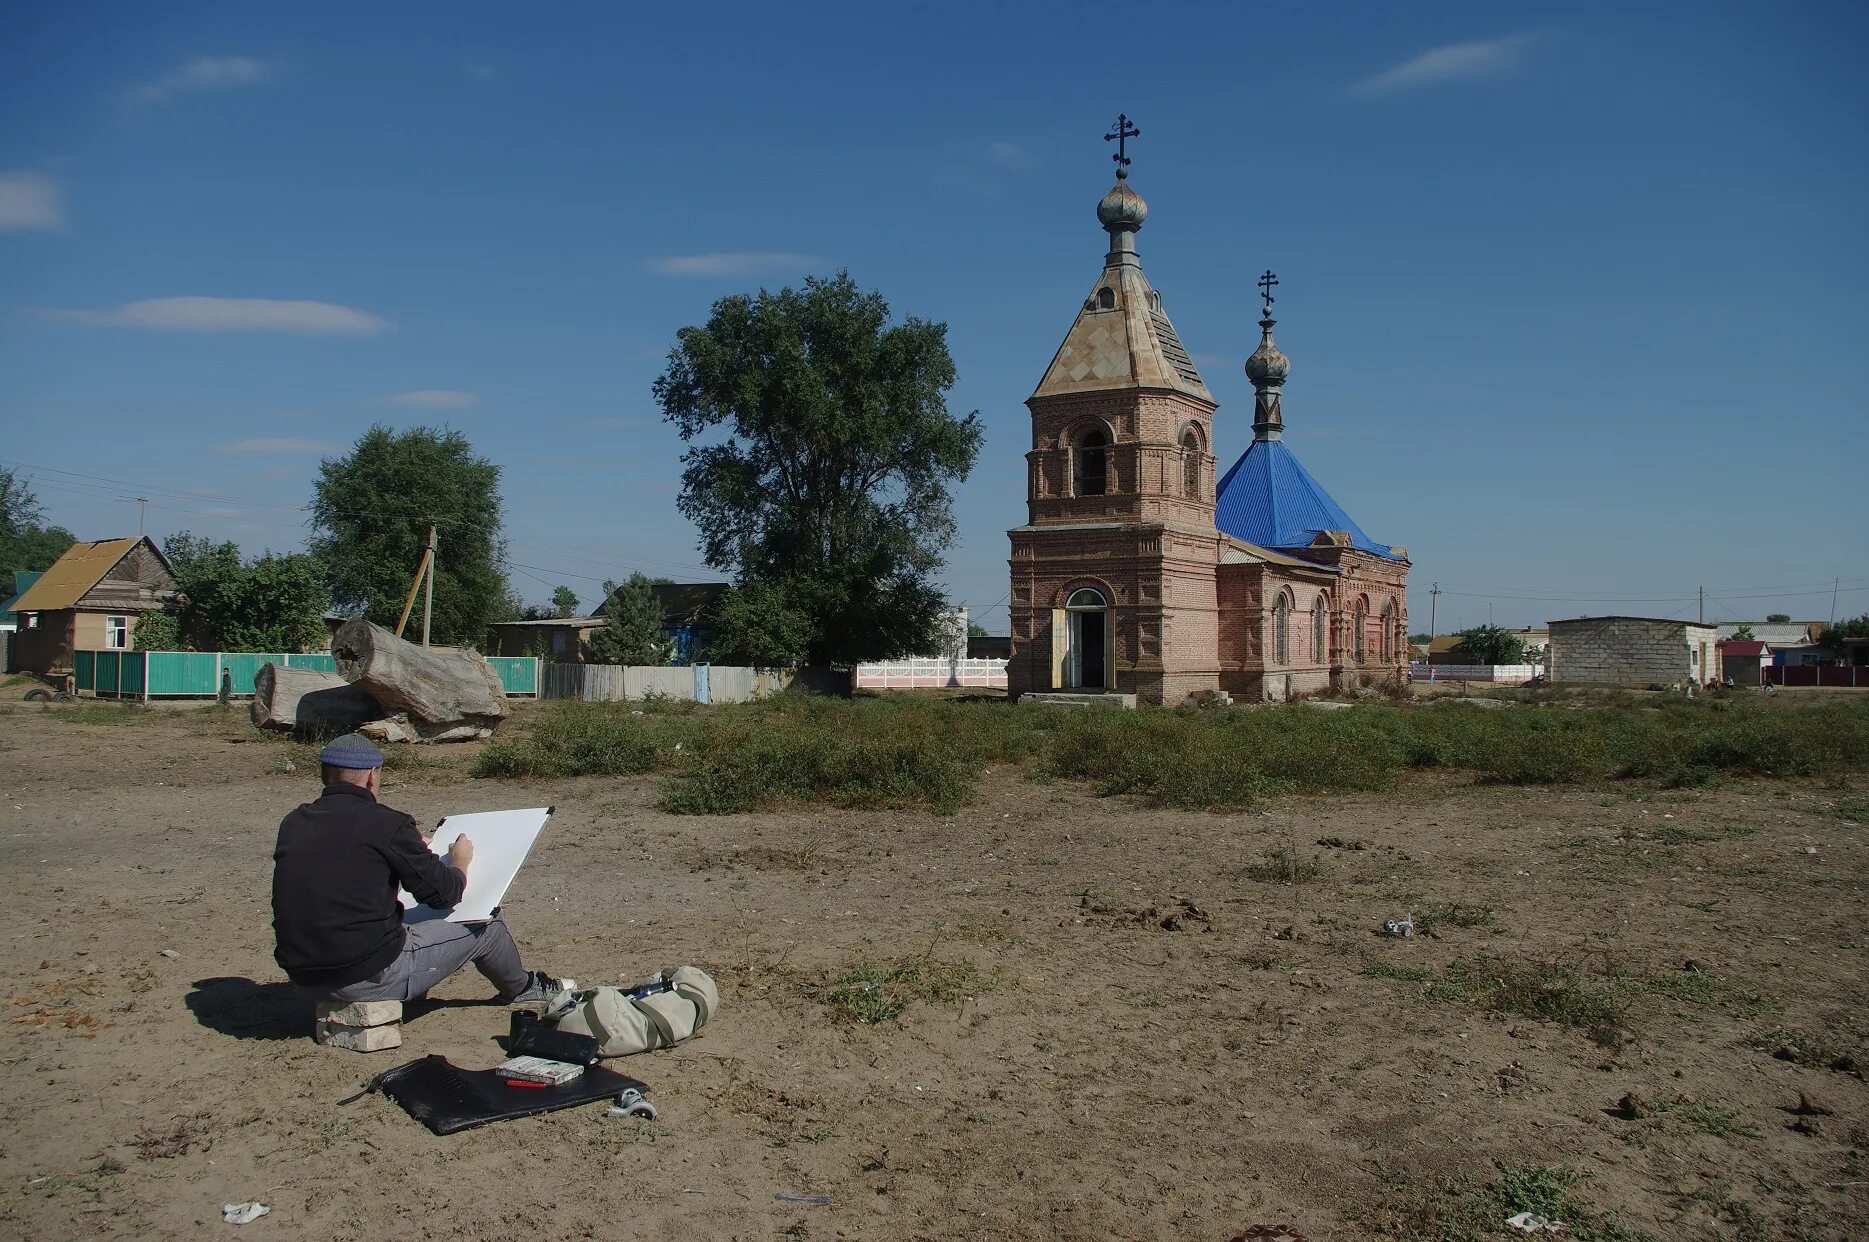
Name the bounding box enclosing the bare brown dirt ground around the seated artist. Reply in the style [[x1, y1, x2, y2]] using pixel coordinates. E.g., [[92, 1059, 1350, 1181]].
[[0, 702, 1869, 1242]]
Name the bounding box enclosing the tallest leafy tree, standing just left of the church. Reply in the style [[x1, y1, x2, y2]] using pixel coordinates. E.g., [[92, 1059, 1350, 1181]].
[[654, 273, 981, 663]]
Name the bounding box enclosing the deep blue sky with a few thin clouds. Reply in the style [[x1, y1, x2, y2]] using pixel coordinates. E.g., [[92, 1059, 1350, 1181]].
[[0, 2, 1869, 631]]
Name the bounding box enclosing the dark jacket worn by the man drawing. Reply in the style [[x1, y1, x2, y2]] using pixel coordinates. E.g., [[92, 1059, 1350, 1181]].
[[273, 784, 467, 988]]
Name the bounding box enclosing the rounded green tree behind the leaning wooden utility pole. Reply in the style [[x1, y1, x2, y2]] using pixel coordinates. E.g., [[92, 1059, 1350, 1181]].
[[312, 426, 508, 646]]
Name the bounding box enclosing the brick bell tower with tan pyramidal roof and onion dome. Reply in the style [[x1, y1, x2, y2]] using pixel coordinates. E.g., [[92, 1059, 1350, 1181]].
[[1007, 116, 1220, 704]]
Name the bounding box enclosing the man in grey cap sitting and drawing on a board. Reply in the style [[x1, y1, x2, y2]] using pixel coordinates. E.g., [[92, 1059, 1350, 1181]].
[[273, 734, 559, 1005]]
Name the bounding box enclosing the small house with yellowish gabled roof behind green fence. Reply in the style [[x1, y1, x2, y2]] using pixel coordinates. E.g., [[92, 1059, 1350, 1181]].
[[13, 538, 176, 676]]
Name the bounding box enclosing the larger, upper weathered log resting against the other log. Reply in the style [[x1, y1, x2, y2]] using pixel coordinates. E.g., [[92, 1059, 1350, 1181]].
[[331, 618, 506, 728]]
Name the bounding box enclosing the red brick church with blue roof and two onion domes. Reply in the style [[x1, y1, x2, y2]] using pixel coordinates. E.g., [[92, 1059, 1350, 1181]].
[[1007, 140, 1409, 704]]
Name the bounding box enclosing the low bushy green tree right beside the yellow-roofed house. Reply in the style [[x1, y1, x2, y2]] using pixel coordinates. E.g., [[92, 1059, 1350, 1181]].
[[160, 530, 329, 652]]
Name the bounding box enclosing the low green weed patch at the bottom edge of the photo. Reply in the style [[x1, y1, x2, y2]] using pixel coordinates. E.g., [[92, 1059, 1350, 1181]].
[[1377, 1162, 1654, 1242]]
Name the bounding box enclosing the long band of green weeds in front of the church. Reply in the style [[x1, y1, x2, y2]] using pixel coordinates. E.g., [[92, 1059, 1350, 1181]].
[[475, 695, 1869, 818]]
